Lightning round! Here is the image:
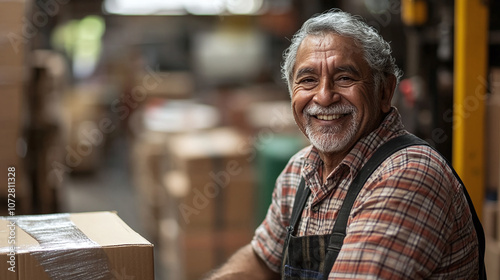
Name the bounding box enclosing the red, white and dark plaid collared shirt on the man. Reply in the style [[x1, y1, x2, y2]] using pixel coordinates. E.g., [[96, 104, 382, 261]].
[[252, 108, 478, 279]]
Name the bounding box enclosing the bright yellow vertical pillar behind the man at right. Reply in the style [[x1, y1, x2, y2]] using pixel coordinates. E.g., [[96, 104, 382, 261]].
[[453, 0, 489, 218]]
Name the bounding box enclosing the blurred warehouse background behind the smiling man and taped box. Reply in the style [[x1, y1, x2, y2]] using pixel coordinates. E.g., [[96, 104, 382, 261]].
[[0, 0, 500, 279]]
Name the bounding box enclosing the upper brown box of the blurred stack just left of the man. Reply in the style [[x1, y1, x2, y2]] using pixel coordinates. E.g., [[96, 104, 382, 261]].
[[164, 128, 255, 229]]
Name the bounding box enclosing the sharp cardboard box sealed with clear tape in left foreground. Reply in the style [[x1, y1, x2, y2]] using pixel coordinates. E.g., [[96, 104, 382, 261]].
[[0, 212, 154, 280]]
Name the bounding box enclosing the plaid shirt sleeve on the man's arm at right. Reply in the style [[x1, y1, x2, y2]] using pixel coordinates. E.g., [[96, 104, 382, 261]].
[[330, 148, 477, 279]]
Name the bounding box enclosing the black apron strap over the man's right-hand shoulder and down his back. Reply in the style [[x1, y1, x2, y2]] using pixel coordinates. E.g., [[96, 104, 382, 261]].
[[320, 134, 486, 280]]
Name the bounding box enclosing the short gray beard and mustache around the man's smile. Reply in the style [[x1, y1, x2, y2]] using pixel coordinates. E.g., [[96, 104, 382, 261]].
[[304, 105, 359, 153]]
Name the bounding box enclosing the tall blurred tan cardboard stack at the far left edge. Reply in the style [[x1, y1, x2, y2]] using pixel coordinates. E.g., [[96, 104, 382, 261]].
[[0, 0, 30, 214]]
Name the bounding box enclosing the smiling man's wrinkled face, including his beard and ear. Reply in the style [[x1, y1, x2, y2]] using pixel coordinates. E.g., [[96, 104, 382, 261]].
[[292, 33, 390, 154]]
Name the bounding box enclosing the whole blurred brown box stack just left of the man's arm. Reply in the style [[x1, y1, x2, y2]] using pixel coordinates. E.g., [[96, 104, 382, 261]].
[[160, 128, 254, 279]]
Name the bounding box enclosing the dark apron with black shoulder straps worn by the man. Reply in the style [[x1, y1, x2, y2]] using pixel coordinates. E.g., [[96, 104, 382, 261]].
[[281, 134, 486, 280]]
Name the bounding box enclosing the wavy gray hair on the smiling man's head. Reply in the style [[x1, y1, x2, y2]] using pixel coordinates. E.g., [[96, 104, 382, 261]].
[[281, 9, 402, 95]]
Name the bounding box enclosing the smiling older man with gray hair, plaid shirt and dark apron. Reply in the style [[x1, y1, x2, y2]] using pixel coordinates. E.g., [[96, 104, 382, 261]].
[[205, 10, 479, 279]]
